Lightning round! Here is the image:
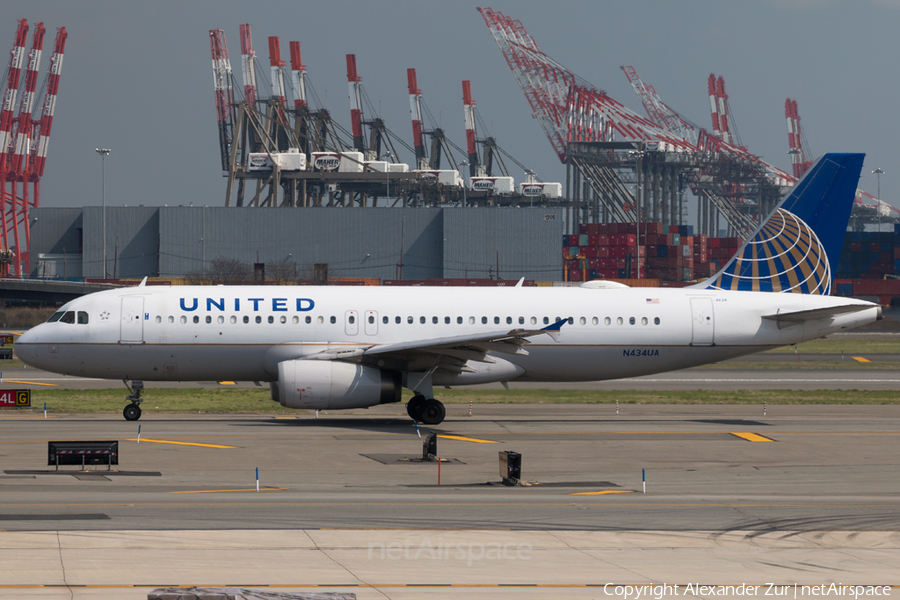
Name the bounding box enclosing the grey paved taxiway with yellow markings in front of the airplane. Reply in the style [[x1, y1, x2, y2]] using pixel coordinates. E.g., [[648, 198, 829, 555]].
[[0, 405, 900, 600]]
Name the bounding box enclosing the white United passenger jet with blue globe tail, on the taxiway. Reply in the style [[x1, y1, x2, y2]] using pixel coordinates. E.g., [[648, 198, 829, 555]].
[[15, 153, 882, 425]]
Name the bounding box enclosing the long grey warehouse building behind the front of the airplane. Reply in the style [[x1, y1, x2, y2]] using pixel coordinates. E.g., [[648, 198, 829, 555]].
[[29, 206, 564, 280]]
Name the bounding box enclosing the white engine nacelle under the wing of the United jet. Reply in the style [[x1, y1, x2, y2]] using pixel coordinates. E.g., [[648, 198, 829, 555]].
[[278, 360, 402, 410]]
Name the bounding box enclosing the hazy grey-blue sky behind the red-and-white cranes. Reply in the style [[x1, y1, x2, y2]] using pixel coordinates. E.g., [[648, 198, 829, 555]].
[[7, 0, 900, 213]]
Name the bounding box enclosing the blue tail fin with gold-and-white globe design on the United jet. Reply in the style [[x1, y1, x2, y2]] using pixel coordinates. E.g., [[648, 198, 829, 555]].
[[695, 154, 865, 295]]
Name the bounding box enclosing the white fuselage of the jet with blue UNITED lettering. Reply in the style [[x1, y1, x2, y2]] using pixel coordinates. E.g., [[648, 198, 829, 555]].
[[16, 286, 879, 385]]
